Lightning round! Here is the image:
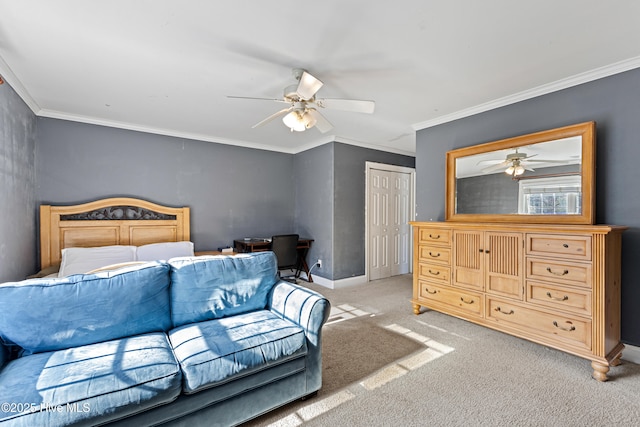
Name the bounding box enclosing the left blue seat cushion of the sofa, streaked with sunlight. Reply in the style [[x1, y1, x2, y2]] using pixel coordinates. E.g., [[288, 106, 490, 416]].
[[0, 332, 181, 426]]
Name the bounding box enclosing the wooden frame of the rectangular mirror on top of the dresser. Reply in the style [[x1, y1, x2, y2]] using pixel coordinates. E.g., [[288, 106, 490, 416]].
[[445, 122, 596, 224]]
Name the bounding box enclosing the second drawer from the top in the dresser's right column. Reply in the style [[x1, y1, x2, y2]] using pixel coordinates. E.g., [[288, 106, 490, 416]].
[[526, 258, 592, 289]]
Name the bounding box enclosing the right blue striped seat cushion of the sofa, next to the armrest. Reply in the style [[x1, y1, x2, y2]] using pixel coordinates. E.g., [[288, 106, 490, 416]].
[[169, 310, 307, 393]]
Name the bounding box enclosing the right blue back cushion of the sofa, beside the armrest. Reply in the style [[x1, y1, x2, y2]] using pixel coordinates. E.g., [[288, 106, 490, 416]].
[[169, 252, 278, 327]]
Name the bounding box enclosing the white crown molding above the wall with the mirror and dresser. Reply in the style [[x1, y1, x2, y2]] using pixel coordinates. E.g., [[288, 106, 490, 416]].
[[411, 56, 640, 131]]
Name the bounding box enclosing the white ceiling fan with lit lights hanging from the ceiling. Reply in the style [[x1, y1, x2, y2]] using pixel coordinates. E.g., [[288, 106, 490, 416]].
[[228, 68, 375, 133]]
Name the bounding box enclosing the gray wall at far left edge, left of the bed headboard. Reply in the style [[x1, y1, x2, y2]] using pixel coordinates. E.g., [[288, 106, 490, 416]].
[[0, 83, 37, 282]]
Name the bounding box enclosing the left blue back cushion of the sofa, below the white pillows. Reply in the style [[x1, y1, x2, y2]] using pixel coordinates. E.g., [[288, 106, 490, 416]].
[[0, 262, 171, 354]]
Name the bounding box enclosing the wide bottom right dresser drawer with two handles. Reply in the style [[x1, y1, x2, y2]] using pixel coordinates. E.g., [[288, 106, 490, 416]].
[[486, 297, 591, 351]]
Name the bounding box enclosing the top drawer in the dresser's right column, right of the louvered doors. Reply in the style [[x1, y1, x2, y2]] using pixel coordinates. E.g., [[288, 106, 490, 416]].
[[526, 234, 591, 261]]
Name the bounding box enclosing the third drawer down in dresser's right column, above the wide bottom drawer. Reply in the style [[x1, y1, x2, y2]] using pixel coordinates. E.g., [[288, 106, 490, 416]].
[[527, 281, 591, 316]]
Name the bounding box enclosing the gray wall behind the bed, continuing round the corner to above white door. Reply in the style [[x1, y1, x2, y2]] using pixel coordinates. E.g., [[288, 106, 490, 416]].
[[36, 118, 415, 280]]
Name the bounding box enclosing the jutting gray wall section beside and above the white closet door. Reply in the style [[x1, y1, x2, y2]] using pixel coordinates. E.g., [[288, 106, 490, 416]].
[[295, 142, 415, 280]]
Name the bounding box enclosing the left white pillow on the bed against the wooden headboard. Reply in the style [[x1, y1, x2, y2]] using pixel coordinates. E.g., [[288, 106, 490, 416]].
[[58, 245, 136, 277]]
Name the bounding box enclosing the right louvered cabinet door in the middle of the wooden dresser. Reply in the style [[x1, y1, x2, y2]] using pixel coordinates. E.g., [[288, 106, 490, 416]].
[[484, 232, 524, 300]]
